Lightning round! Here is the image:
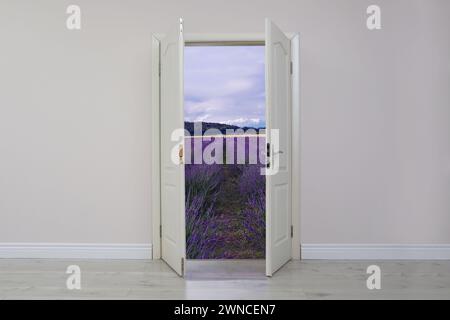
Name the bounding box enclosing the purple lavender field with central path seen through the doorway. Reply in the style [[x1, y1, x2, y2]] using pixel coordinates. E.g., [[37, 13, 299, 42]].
[[185, 136, 265, 259]]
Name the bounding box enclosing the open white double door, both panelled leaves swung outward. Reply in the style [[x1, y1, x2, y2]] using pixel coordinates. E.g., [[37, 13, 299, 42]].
[[160, 20, 292, 276]]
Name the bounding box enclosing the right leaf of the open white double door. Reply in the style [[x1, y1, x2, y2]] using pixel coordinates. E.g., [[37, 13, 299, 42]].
[[266, 20, 292, 276]]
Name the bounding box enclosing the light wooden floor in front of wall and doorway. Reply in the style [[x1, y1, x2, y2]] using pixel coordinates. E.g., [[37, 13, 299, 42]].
[[0, 259, 450, 299]]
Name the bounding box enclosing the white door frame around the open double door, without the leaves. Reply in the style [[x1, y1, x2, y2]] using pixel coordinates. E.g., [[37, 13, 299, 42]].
[[150, 32, 301, 260]]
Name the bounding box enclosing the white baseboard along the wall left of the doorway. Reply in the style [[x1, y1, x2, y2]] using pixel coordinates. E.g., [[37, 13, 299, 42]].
[[0, 243, 152, 260]]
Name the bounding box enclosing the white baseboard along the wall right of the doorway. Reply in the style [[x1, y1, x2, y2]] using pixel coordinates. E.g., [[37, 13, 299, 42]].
[[301, 244, 450, 260]]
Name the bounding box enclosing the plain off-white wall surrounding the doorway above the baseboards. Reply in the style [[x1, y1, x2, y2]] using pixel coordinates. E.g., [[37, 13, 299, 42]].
[[0, 0, 450, 248]]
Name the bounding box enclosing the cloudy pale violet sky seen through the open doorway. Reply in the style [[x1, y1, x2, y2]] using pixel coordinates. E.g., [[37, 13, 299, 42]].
[[184, 46, 265, 127]]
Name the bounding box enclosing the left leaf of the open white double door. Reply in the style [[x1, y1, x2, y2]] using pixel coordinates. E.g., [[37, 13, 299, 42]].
[[160, 21, 186, 276]]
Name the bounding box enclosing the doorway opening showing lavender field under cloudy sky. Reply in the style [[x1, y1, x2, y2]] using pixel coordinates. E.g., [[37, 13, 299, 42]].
[[184, 42, 266, 260]]
